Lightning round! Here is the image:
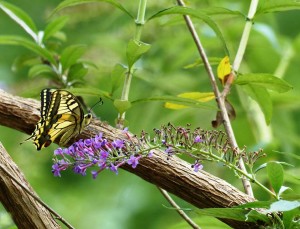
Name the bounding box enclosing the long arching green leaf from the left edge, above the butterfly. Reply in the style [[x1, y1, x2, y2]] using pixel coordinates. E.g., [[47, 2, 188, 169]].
[[0, 36, 56, 65]]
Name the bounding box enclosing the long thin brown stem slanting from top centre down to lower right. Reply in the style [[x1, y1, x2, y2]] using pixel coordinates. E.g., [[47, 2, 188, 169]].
[[177, 0, 253, 197]]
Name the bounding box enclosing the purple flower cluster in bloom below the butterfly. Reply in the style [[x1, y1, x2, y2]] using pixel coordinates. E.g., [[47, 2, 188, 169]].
[[52, 133, 143, 178]]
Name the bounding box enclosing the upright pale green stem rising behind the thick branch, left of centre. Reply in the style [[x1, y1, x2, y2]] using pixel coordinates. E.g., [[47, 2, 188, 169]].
[[117, 0, 147, 129]]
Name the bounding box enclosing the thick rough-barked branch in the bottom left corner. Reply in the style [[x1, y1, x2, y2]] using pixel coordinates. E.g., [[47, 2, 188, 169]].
[[0, 143, 60, 229]]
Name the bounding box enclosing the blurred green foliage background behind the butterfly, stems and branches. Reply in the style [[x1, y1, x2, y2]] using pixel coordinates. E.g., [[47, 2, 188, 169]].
[[0, 0, 300, 229]]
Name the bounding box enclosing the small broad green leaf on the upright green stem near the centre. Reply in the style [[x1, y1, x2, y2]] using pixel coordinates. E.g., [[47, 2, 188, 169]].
[[126, 39, 151, 68]]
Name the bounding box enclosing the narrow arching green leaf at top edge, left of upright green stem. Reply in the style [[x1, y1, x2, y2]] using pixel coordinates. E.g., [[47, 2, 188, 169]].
[[51, 0, 134, 18]]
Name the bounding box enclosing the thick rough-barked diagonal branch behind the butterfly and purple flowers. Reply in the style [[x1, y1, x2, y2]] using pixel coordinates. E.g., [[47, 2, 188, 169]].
[[0, 90, 258, 228]]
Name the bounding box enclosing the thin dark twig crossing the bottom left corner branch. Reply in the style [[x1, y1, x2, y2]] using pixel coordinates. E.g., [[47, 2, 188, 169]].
[[0, 164, 74, 229]]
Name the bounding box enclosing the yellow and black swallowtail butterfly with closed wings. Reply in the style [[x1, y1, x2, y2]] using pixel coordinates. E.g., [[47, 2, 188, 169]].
[[25, 88, 92, 150]]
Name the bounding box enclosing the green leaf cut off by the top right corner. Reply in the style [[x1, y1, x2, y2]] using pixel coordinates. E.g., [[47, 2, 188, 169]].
[[256, 0, 300, 15]]
